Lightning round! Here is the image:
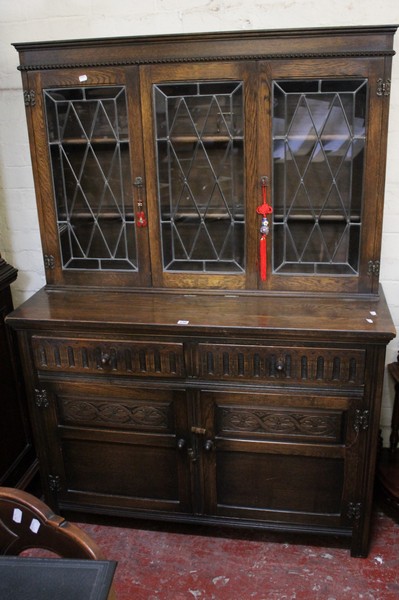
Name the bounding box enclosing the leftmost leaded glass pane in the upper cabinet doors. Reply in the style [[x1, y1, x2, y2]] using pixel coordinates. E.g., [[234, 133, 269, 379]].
[[44, 86, 137, 271]]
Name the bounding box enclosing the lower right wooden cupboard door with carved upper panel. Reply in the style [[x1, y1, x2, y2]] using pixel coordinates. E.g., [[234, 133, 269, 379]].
[[202, 391, 360, 528]]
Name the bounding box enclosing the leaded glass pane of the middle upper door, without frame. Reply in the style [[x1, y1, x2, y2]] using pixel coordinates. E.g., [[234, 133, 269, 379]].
[[154, 82, 245, 273]]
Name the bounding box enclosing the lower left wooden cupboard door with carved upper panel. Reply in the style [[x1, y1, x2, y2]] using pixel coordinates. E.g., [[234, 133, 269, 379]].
[[38, 382, 191, 513]]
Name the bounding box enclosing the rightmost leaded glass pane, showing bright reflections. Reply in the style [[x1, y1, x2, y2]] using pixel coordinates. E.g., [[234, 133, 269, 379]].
[[273, 79, 367, 276]]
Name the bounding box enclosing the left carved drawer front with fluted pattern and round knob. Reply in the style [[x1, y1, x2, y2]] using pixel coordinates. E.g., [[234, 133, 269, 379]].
[[32, 336, 185, 377]]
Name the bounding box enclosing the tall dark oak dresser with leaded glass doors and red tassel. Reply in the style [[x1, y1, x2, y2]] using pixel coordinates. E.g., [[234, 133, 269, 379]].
[[8, 26, 396, 556]]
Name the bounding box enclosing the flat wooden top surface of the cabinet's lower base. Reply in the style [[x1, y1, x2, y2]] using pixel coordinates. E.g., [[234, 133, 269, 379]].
[[7, 288, 395, 342]]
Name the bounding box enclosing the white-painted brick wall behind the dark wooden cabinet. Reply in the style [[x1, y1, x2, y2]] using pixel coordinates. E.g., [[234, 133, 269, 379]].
[[0, 0, 399, 441]]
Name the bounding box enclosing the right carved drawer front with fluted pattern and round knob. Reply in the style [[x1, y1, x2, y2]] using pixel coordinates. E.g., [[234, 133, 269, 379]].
[[199, 344, 365, 387]]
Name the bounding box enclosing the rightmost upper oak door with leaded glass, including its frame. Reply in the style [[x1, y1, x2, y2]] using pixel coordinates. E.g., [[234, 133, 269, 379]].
[[259, 59, 387, 293]]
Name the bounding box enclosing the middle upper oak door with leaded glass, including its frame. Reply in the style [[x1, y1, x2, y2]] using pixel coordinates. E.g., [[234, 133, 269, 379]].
[[141, 63, 256, 289]]
